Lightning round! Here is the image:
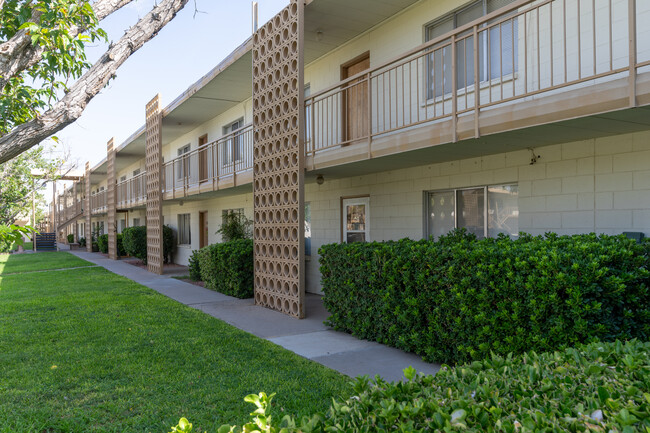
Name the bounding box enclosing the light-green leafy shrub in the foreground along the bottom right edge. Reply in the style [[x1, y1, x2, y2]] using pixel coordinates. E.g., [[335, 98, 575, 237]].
[[172, 341, 650, 433]]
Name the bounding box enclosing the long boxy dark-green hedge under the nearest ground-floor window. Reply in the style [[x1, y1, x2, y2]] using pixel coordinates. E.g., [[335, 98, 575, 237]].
[[319, 232, 650, 363]]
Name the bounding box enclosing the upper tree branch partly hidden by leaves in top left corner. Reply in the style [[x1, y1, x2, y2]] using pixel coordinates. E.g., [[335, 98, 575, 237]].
[[0, 0, 133, 89]]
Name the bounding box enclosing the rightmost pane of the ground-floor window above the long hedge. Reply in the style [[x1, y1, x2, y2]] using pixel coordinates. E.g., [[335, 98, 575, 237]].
[[488, 185, 519, 237]]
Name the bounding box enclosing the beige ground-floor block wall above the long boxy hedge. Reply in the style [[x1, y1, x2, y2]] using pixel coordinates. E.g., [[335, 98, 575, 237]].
[[305, 132, 650, 293]]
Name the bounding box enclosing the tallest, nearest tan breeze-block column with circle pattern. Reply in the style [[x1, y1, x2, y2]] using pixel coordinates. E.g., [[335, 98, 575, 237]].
[[253, 0, 305, 318]]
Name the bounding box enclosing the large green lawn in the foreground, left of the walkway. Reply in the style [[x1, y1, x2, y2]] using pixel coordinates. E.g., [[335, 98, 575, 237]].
[[0, 253, 351, 433]]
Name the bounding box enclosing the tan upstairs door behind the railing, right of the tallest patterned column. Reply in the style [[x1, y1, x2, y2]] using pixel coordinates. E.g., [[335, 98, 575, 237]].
[[341, 52, 370, 144]]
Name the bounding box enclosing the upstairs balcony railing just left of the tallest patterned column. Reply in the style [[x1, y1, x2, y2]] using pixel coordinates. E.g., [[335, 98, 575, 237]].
[[163, 125, 253, 195]]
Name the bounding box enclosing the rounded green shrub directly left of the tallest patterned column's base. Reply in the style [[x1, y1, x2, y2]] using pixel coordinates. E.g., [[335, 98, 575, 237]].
[[199, 239, 253, 299]]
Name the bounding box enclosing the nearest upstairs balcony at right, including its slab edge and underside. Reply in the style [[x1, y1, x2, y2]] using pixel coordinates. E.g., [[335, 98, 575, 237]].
[[305, 0, 650, 172]]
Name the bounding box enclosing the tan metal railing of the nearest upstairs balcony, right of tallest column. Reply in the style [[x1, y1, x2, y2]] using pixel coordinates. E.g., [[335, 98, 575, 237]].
[[305, 0, 650, 155]]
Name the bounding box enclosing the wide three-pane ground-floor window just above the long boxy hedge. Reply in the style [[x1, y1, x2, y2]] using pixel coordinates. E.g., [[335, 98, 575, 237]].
[[427, 184, 519, 238]]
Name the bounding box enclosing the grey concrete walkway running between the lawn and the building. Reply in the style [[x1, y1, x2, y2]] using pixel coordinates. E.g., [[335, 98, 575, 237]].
[[70, 251, 440, 381]]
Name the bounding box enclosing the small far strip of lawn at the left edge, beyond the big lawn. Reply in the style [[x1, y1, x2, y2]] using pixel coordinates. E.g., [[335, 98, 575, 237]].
[[0, 252, 94, 275]]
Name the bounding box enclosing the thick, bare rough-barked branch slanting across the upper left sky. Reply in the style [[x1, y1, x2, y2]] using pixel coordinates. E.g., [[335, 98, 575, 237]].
[[0, 0, 189, 163]]
